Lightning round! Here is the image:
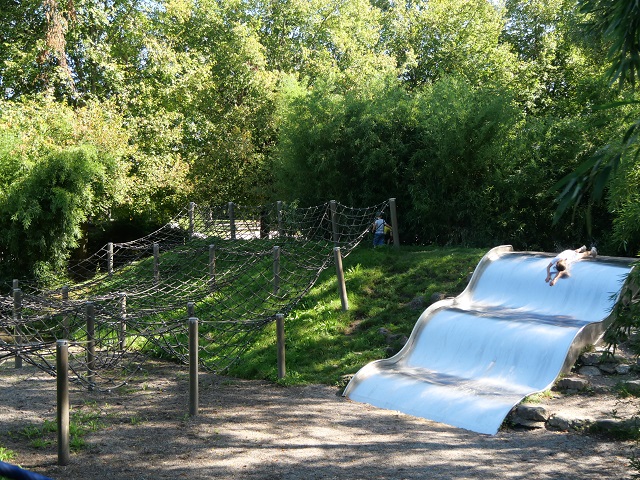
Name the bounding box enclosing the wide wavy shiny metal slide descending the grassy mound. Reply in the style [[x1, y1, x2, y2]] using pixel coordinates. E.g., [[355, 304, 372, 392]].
[[343, 246, 634, 435]]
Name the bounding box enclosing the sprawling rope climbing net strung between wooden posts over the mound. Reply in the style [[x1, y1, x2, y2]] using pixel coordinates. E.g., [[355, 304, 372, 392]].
[[0, 201, 389, 390]]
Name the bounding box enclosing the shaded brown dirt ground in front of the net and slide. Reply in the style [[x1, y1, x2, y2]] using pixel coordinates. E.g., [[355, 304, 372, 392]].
[[0, 362, 638, 480]]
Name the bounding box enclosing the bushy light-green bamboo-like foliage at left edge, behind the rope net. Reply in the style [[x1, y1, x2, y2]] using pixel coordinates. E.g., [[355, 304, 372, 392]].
[[0, 96, 132, 276]]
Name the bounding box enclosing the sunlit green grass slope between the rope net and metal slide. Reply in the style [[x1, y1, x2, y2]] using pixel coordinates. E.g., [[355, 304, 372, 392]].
[[229, 245, 487, 386]]
